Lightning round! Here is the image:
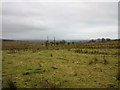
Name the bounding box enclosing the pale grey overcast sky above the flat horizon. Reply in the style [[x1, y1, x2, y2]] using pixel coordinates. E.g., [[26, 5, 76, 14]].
[[2, 2, 118, 40]]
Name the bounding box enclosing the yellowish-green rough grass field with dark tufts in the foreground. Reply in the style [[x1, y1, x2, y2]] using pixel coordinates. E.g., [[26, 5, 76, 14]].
[[2, 42, 119, 88]]
